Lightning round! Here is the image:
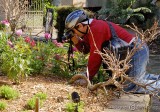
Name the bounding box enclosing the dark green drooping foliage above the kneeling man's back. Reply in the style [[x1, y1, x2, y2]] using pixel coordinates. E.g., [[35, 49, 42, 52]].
[[98, 0, 157, 30]]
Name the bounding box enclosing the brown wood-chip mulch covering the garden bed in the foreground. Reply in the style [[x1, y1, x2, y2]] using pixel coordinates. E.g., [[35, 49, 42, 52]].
[[0, 76, 110, 112]]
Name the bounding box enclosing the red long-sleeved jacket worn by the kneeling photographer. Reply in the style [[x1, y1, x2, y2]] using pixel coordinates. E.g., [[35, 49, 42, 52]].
[[75, 19, 133, 79]]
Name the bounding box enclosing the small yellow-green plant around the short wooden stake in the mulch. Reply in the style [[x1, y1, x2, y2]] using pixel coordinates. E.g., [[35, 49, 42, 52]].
[[26, 92, 47, 109]]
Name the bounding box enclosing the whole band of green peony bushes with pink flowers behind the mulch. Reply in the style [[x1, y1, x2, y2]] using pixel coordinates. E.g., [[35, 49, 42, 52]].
[[0, 31, 87, 83]]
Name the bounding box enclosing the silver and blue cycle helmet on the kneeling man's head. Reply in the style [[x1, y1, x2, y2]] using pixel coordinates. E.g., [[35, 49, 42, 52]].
[[65, 10, 88, 30]]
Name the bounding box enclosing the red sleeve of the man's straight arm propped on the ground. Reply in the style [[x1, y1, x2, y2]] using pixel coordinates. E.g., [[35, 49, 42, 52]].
[[88, 28, 108, 80]]
